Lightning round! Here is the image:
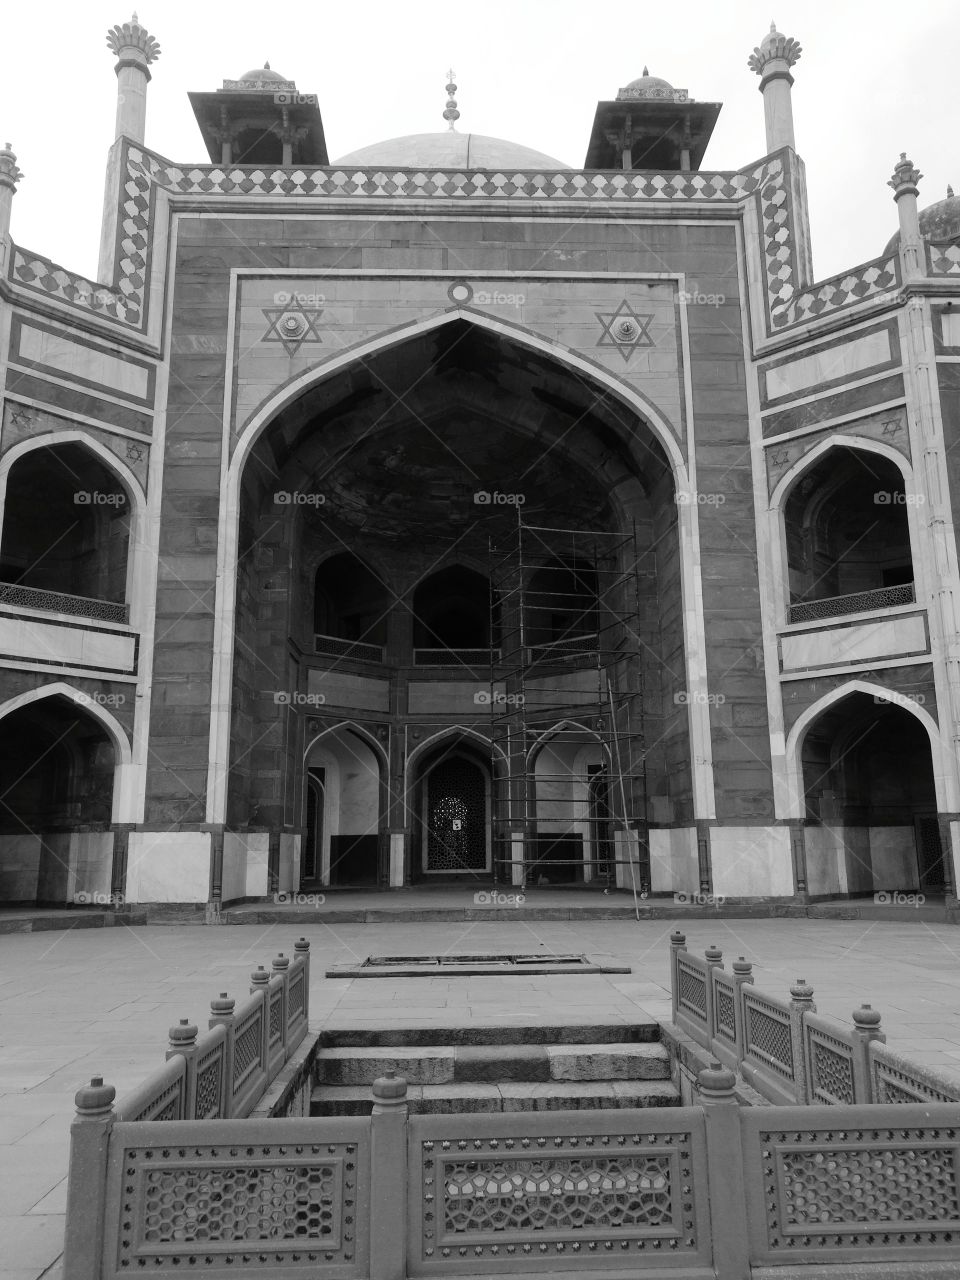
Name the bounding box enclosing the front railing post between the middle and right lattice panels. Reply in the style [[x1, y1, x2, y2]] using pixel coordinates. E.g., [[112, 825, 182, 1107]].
[[696, 1062, 750, 1280]]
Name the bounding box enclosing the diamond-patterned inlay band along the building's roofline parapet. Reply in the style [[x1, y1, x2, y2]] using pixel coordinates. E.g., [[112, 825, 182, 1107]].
[[1, 142, 870, 345]]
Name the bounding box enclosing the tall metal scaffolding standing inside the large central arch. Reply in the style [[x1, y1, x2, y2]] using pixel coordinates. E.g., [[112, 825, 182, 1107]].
[[489, 508, 650, 896]]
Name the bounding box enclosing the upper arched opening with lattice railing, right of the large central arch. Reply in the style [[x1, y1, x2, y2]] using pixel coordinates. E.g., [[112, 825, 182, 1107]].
[[783, 447, 914, 622]]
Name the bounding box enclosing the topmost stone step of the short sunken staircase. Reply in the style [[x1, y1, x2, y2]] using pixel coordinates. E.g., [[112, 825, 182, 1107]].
[[320, 1012, 660, 1048]]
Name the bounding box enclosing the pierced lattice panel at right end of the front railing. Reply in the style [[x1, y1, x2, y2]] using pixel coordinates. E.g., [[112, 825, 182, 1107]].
[[759, 1129, 960, 1249]]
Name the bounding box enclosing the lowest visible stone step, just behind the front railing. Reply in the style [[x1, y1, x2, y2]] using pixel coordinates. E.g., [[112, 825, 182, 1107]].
[[310, 1080, 680, 1116]]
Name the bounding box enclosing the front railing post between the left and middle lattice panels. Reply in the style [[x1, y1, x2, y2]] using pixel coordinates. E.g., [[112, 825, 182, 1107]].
[[370, 1071, 407, 1280]]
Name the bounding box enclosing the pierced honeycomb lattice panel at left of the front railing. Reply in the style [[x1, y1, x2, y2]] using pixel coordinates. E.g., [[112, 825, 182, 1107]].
[[118, 1143, 357, 1275]]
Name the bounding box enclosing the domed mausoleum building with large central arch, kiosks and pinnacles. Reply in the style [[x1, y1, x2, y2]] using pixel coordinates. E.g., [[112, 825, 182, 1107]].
[[0, 17, 960, 908]]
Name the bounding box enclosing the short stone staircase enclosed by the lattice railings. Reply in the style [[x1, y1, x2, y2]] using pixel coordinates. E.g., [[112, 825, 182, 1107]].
[[310, 1023, 680, 1116]]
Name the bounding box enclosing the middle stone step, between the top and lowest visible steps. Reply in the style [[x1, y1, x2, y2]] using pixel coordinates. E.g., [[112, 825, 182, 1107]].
[[316, 1042, 671, 1085]]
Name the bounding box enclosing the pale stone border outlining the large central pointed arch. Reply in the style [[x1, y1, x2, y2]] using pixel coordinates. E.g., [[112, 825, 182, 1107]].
[[206, 307, 716, 822]]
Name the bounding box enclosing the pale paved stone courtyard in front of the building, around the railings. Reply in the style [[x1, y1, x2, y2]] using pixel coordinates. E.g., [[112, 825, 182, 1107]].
[[0, 915, 960, 1280]]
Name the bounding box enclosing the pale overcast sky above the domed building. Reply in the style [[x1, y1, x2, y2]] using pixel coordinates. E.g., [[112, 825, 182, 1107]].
[[0, 0, 960, 279]]
